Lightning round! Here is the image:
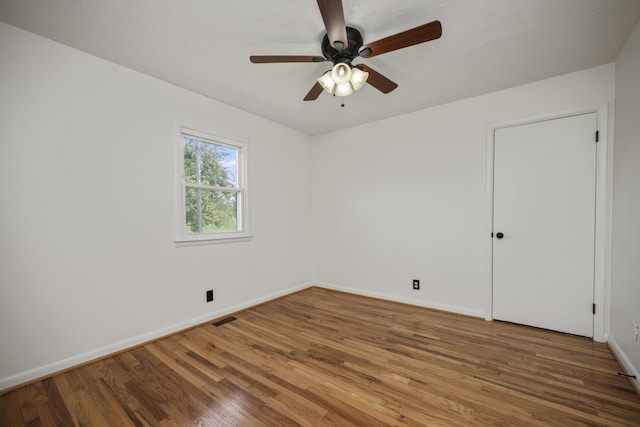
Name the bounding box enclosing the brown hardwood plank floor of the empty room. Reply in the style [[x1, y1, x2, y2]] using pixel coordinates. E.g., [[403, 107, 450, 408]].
[[0, 288, 640, 427]]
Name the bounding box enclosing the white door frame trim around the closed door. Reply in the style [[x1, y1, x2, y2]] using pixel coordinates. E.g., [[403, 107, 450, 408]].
[[485, 104, 613, 342]]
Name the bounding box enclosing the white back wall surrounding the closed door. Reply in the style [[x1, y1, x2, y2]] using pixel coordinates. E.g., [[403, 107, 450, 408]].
[[312, 64, 614, 316]]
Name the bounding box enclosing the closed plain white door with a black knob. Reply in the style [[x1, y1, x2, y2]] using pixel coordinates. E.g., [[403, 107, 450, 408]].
[[493, 113, 596, 337]]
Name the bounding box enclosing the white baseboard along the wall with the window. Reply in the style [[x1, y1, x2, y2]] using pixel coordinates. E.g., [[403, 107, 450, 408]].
[[0, 283, 313, 392]]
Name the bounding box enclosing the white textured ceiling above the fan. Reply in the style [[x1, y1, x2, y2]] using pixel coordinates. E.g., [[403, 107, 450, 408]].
[[0, 0, 640, 135]]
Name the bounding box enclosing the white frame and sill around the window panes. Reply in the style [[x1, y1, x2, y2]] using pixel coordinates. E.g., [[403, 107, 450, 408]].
[[174, 126, 252, 247]]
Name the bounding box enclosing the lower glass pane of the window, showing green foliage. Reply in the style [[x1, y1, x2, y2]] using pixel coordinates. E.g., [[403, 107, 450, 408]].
[[185, 188, 238, 234]]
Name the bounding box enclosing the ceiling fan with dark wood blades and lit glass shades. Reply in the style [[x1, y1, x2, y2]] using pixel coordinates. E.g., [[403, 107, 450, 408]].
[[249, 0, 442, 101]]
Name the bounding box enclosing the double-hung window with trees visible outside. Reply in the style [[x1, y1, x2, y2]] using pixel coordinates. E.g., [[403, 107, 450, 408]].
[[178, 129, 249, 242]]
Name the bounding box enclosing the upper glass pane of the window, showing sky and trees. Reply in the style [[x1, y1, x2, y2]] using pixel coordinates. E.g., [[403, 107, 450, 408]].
[[183, 136, 238, 187]]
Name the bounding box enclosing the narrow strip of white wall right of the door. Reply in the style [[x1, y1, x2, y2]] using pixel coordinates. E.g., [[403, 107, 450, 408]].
[[610, 19, 640, 387]]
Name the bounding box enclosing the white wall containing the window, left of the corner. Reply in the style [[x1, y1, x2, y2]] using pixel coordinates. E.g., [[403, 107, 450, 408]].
[[0, 23, 311, 389]]
